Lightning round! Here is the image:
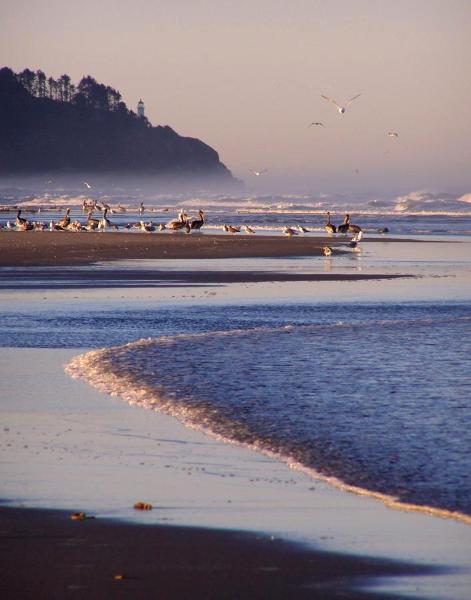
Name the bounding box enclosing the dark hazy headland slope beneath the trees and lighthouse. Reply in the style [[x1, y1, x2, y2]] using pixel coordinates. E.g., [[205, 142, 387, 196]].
[[0, 68, 233, 180]]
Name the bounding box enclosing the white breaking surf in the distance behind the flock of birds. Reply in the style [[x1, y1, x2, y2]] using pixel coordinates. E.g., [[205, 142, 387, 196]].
[[0, 187, 471, 217]]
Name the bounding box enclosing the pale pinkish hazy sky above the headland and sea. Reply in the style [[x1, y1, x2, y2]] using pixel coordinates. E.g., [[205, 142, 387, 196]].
[[0, 0, 471, 194]]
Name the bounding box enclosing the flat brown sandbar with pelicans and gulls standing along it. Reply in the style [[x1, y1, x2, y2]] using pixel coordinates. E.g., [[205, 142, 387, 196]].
[[0, 231, 412, 266]]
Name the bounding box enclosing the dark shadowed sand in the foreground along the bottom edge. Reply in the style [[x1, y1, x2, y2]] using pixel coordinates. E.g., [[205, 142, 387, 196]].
[[0, 508, 432, 600]]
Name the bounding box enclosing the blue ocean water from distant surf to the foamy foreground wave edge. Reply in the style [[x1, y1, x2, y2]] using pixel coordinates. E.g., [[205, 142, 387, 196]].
[[0, 186, 471, 520]]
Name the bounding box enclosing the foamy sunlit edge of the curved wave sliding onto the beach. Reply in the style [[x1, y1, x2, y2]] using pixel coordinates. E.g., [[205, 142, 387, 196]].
[[65, 317, 471, 525]]
